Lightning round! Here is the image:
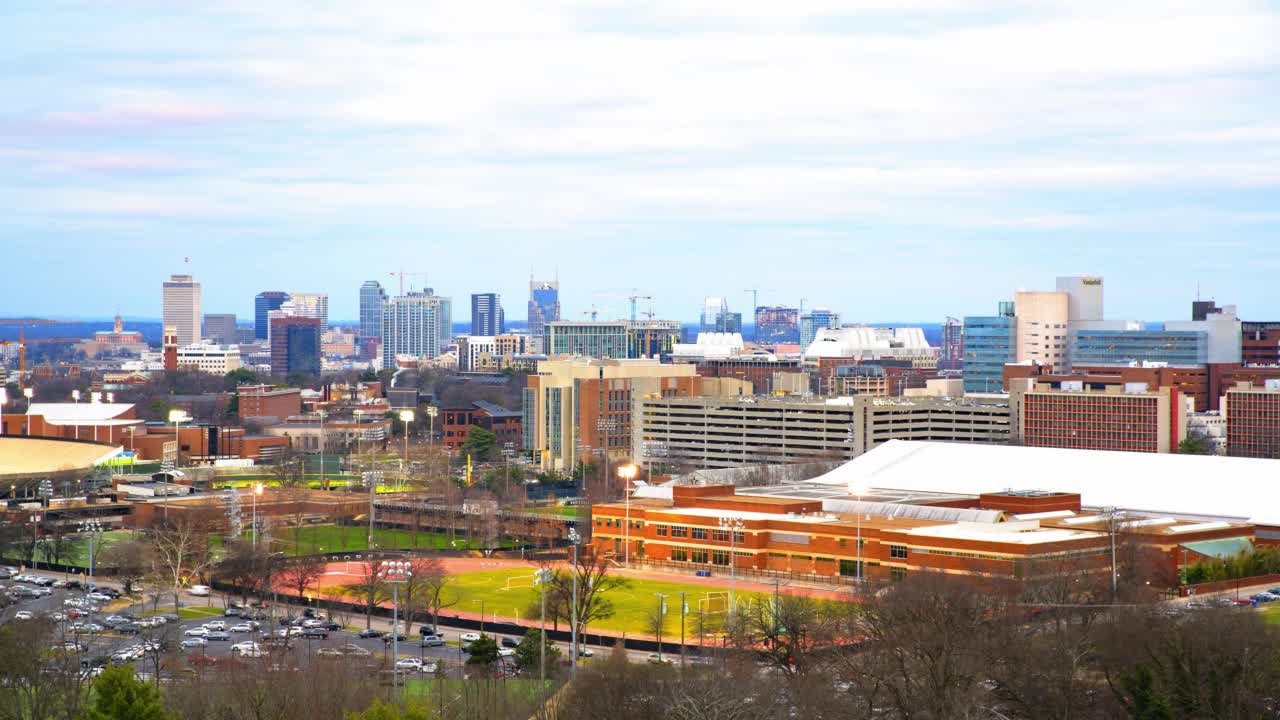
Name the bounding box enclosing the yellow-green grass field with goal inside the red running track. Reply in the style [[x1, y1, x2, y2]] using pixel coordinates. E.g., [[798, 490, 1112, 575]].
[[444, 569, 764, 637]]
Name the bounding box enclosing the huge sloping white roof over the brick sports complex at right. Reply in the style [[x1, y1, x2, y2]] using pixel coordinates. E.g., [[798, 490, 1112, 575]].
[[809, 439, 1280, 525]]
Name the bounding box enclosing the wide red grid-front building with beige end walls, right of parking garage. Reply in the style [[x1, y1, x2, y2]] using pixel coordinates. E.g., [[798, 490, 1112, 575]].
[[1010, 383, 1187, 452]]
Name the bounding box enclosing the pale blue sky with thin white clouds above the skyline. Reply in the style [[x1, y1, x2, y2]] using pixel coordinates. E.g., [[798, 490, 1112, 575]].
[[0, 0, 1280, 322]]
